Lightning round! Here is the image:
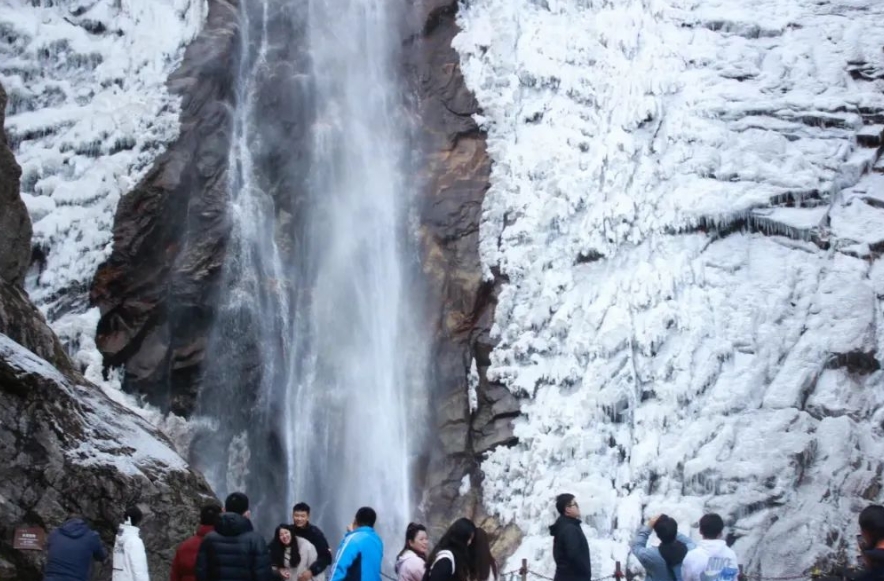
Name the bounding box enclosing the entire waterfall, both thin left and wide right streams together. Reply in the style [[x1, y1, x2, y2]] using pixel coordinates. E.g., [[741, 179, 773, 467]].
[[194, 0, 427, 544]]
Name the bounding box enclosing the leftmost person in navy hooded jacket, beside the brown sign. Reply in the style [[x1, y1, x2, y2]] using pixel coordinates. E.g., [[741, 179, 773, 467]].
[[43, 518, 107, 581]]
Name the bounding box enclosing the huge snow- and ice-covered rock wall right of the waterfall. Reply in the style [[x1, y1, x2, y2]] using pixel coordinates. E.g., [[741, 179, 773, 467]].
[[455, 0, 884, 577]]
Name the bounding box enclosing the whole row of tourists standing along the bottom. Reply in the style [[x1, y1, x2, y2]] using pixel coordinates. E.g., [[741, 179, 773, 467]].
[[38, 492, 884, 581]]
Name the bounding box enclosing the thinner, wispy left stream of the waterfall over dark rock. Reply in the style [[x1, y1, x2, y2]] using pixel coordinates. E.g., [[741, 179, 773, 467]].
[[193, 2, 290, 522]]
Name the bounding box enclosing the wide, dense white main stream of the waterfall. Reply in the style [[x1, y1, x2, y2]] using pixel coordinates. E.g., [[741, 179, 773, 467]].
[[288, 0, 426, 541]]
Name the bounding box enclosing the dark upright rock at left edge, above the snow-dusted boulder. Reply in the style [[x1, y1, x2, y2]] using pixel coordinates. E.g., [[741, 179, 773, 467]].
[[0, 87, 31, 286]]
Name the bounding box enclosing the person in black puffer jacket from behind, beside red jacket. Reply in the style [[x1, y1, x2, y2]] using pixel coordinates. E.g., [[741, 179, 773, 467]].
[[196, 492, 273, 581]]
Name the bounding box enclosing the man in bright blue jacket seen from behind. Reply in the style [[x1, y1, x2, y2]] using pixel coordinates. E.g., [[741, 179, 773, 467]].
[[330, 506, 384, 581]]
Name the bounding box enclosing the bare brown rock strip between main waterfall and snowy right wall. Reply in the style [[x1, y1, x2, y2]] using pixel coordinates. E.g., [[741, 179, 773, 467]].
[[406, 0, 519, 552]]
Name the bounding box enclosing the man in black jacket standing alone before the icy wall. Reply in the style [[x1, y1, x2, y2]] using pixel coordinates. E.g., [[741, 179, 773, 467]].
[[549, 494, 592, 581]]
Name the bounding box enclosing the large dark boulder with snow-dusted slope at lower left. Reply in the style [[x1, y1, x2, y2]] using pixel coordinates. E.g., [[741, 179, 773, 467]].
[[0, 82, 211, 581]]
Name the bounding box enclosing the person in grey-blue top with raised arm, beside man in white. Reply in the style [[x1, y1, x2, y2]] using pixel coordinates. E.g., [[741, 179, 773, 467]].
[[631, 514, 697, 581]]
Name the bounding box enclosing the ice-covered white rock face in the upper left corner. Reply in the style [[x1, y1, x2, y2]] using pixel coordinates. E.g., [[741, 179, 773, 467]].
[[0, 0, 207, 318]]
